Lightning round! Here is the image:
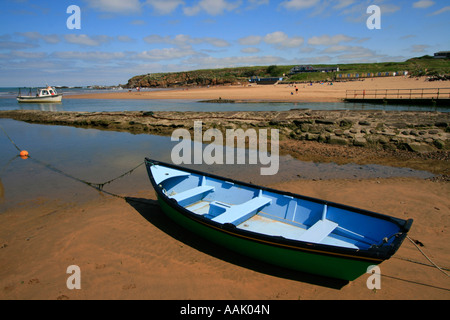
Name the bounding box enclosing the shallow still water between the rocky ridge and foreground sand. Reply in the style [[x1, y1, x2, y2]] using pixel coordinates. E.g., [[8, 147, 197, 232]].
[[0, 119, 433, 212]]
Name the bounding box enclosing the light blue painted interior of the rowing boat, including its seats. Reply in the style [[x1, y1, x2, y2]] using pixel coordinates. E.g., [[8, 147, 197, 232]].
[[151, 165, 399, 249]]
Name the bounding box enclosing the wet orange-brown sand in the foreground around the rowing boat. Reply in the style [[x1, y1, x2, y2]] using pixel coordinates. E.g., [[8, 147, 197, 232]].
[[0, 178, 450, 300]]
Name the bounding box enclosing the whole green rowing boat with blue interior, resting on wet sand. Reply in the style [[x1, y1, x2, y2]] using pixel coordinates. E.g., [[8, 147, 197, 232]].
[[145, 159, 413, 281]]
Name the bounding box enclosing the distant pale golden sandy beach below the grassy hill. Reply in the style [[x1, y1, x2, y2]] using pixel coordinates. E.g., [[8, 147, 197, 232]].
[[64, 77, 450, 102]]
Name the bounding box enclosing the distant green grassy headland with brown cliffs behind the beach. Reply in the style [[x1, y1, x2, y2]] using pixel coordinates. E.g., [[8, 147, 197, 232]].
[[125, 56, 450, 88]]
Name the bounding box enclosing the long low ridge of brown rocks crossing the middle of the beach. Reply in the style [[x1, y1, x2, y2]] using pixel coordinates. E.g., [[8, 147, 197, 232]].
[[0, 110, 450, 153]]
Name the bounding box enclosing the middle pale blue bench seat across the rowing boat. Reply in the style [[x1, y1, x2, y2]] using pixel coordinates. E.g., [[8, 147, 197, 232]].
[[212, 196, 272, 225]]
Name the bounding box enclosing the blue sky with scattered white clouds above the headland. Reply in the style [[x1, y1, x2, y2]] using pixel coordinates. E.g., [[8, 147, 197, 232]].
[[0, 0, 450, 87]]
